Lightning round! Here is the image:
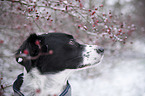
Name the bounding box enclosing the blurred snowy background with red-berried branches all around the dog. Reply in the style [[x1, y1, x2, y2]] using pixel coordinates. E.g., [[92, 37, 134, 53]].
[[0, 0, 145, 96]]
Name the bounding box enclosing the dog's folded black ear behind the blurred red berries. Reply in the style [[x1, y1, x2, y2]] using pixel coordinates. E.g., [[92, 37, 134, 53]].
[[15, 34, 41, 72]]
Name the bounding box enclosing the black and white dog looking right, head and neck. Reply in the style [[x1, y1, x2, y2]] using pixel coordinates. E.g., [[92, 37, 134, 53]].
[[14, 33, 104, 96]]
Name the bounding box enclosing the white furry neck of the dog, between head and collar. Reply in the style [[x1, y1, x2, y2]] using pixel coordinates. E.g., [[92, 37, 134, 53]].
[[22, 68, 73, 96]]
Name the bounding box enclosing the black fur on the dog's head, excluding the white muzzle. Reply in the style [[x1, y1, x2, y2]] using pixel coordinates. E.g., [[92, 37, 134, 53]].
[[16, 33, 84, 74]]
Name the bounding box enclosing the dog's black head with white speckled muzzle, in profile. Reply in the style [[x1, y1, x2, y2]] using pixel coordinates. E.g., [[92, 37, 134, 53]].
[[16, 33, 104, 73]]
